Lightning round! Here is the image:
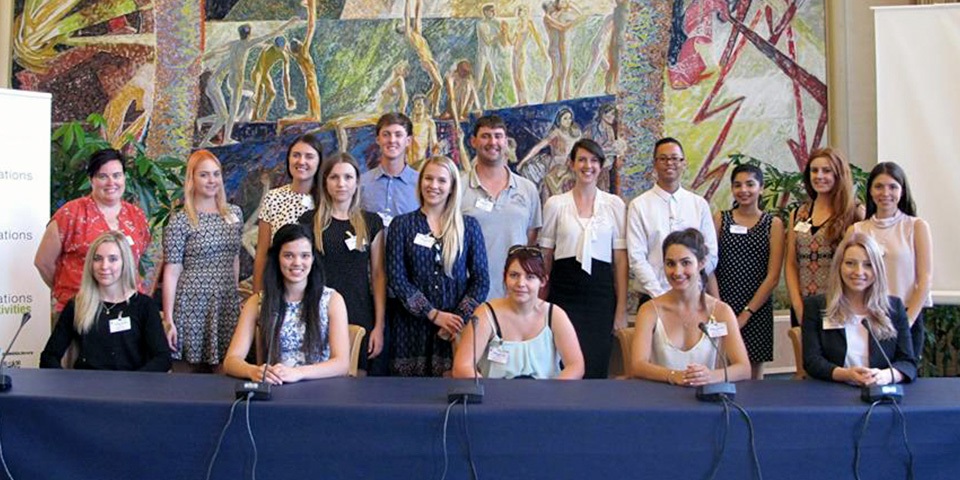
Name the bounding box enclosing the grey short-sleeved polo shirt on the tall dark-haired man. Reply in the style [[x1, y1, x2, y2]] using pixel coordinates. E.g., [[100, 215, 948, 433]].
[[460, 167, 543, 298]]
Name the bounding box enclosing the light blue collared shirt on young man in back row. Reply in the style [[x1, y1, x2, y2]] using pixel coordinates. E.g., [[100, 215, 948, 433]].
[[360, 165, 420, 228]]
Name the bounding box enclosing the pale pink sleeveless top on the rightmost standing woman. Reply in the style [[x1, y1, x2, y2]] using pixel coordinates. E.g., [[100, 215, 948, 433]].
[[853, 210, 933, 307]]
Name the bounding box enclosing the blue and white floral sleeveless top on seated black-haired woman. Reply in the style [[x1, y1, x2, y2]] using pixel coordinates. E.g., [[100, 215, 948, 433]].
[[278, 287, 334, 367]]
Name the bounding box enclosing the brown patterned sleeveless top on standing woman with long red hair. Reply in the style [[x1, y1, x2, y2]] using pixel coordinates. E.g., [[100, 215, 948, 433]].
[[794, 204, 836, 298]]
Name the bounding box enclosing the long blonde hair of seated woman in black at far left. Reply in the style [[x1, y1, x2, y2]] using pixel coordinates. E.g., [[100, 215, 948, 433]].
[[73, 231, 137, 334]]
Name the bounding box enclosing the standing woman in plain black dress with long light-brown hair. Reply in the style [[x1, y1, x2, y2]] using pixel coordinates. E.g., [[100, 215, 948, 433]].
[[300, 153, 387, 376]]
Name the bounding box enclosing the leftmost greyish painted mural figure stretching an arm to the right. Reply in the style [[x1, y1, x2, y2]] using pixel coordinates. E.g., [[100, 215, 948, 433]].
[[197, 20, 293, 146]]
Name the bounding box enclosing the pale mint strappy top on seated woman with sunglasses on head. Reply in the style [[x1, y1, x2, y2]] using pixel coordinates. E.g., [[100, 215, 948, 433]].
[[478, 302, 560, 379]]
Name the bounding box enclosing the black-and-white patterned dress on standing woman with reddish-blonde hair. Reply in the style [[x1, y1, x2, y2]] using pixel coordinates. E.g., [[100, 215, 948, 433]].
[[163, 205, 243, 365]]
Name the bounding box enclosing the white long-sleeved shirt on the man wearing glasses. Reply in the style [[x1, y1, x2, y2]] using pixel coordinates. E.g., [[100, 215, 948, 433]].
[[627, 185, 717, 297]]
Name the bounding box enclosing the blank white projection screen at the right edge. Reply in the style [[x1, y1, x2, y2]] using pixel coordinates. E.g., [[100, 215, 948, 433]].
[[874, 4, 960, 304]]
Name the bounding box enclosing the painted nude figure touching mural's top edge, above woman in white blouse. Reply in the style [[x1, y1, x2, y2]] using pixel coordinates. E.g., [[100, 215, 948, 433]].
[[543, 0, 585, 103]]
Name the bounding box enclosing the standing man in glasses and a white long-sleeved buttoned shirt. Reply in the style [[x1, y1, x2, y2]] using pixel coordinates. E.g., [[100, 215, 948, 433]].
[[627, 137, 717, 305]]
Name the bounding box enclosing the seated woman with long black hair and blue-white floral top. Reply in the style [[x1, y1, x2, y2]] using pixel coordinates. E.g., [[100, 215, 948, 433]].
[[223, 224, 350, 385]]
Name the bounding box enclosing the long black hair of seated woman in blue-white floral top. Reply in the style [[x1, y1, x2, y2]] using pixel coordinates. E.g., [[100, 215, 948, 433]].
[[259, 223, 326, 364]]
